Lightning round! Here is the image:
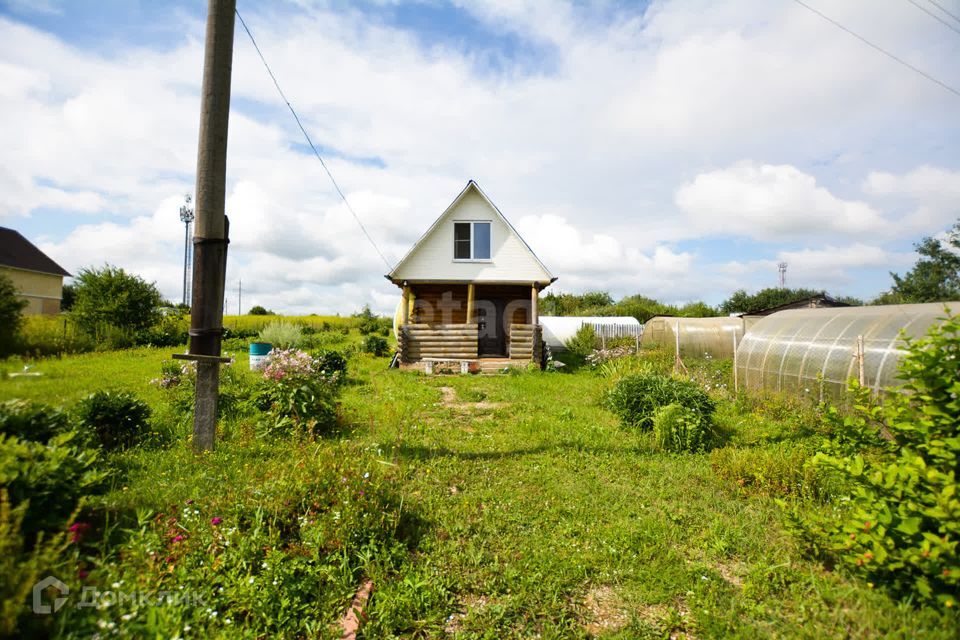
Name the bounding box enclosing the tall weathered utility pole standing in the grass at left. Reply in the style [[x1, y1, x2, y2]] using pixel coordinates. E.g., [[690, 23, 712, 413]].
[[185, 0, 237, 451]]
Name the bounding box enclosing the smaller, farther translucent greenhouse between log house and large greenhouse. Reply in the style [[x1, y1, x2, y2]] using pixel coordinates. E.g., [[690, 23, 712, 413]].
[[640, 316, 753, 358]]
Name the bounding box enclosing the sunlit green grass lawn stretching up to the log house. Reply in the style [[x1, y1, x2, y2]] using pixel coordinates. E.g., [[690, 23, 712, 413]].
[[0, 349, 958, 638]]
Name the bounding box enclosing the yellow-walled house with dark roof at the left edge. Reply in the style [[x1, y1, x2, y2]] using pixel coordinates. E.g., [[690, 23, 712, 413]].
[[0, 227, 70, 315]]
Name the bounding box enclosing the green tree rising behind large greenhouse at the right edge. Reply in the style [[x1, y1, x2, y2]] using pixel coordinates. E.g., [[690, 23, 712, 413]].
[[873, 219, 960, 304]]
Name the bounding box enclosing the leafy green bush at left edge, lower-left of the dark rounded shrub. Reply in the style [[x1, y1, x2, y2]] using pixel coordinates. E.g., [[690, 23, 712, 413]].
[[0, 431, 106, 535]]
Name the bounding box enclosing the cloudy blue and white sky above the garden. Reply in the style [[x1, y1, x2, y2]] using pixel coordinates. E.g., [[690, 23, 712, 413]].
[[0, 0, 960, 314]]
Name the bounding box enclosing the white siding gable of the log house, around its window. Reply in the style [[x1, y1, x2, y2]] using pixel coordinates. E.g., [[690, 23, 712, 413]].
[[388, 180, 553, 284]]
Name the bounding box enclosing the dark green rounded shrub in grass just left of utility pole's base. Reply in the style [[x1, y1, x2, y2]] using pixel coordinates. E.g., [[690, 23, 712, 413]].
[[76, 390, 150, 451]]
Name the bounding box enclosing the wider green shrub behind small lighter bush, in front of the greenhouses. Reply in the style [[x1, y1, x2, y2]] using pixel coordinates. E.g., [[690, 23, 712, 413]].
[[604, 373, 715, 429]]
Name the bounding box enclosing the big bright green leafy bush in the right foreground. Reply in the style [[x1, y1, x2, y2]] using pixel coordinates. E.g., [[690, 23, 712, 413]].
[[795, 315, 960, 609]]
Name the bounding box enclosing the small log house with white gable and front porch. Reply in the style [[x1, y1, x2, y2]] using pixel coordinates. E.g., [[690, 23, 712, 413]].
[[386, 180, 556, 371]]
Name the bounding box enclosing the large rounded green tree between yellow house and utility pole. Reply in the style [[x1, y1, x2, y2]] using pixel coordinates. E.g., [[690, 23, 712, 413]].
[[70, 265, 162, 334]]
